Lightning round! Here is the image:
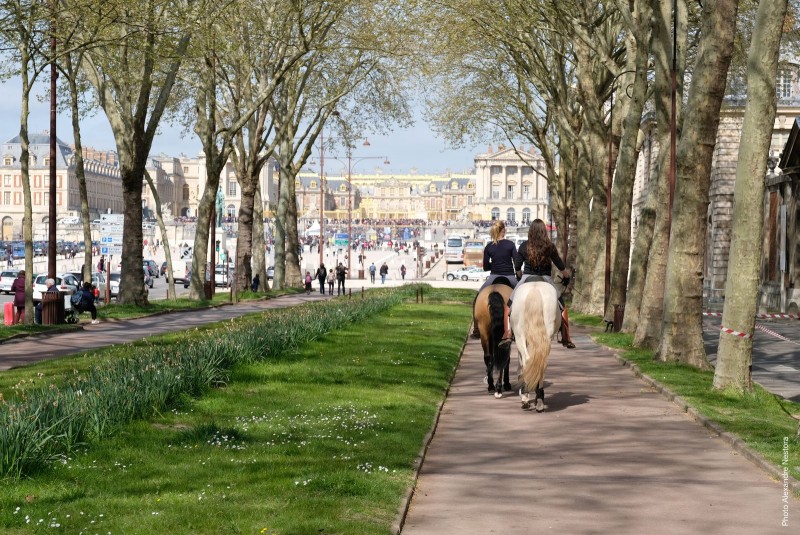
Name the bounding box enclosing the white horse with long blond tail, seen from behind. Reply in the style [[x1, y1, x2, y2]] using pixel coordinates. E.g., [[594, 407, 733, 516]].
[[510, 281, 561, 412]]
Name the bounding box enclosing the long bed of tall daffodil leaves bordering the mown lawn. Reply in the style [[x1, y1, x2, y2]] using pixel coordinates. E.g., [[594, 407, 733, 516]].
[[0, 287, 432, 478]]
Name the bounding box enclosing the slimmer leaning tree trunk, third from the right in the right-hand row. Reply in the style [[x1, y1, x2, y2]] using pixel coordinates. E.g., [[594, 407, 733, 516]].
[[633, 0, 687, 349]]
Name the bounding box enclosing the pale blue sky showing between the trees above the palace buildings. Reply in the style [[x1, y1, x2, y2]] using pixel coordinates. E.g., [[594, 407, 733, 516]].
[[0, 78, 486, 175]]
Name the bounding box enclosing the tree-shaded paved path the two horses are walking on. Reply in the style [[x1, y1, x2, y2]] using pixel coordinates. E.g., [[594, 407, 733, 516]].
[[402, 326, 800, 535]]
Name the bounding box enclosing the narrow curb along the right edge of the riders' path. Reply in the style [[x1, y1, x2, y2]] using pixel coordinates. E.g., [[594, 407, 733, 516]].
[[612, 350, 800, 495]]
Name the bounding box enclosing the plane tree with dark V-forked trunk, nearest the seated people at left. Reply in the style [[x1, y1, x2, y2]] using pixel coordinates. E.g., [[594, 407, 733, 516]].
[[81, 0, 202, 305]]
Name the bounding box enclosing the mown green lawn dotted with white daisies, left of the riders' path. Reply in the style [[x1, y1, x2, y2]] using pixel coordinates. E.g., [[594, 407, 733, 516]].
[[0, 290, 472, 535]]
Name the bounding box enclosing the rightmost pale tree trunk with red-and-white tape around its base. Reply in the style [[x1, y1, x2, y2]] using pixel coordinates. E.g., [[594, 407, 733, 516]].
[[714, 0, 787, 391]]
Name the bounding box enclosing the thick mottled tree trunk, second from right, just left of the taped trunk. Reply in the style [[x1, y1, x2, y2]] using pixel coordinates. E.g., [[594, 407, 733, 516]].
[[656, 0, 738, 369]]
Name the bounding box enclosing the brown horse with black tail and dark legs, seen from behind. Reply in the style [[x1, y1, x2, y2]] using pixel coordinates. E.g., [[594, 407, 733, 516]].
[[472, 279, 512, 398]]
